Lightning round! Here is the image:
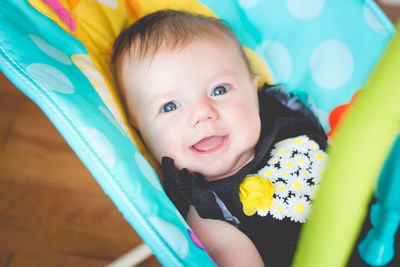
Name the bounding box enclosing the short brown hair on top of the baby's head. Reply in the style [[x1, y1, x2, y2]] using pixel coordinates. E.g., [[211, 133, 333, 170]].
[[112, 10, 253, 74]]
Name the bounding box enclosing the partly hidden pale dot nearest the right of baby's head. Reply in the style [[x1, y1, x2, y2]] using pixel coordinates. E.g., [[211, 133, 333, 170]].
[[256, 41, 292, 83]]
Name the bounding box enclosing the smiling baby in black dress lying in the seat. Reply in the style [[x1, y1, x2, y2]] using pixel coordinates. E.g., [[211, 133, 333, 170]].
[[113, 11, 326, 266]]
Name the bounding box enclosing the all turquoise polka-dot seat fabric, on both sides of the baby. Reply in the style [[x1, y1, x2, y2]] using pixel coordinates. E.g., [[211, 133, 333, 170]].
[[0, 0, 394, 266]]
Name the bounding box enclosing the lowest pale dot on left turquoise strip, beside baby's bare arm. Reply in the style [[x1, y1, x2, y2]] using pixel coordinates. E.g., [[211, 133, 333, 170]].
[[149, 216, 189, 259]]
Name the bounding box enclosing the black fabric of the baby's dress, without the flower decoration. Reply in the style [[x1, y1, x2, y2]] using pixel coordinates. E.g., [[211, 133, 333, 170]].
[[163, 86, 327, 266]]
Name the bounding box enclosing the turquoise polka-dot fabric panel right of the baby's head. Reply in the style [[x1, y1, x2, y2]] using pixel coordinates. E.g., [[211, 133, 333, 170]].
[[201, 0, 394, 131]]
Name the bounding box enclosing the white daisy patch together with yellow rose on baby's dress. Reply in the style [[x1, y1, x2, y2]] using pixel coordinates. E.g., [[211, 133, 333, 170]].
[[239, 135, 328, 223]]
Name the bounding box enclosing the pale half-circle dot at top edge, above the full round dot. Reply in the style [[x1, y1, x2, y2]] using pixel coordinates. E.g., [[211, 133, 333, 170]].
[[286, 0, 325, 20]]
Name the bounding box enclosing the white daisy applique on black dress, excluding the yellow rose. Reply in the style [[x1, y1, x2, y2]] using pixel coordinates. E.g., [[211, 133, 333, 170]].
[[247, 135, 328, 223]]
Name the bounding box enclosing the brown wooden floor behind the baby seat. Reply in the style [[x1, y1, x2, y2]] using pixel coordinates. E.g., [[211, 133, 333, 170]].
[[0, 2, 400, 267]]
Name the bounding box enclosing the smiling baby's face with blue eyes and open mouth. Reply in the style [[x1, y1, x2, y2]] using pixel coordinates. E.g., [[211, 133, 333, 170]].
[[120, 38, 261, 180]]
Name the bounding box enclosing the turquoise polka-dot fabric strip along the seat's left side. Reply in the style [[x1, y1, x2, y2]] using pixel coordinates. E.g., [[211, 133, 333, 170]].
[[0, 0, 214, 266]]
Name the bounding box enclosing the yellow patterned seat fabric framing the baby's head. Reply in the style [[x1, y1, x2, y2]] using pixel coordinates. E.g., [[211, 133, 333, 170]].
[[29, 0, 272, 173]]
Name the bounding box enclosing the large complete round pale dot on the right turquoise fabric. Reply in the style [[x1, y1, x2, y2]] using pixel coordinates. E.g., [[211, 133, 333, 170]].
[[310, 40, 354, 89]]
